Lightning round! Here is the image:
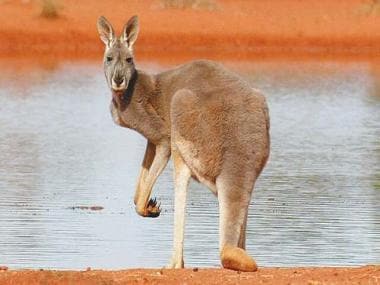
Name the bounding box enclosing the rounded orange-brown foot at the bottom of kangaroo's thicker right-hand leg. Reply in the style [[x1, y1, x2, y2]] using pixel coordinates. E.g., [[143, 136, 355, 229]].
[[220, 245, 257, 272]]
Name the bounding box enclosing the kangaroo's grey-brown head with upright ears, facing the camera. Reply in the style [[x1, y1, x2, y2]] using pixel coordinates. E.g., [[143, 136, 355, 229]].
[[98, 16, 139, 94]]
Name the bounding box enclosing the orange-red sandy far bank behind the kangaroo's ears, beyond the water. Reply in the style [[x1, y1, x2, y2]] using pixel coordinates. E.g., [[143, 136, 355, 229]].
[[0, 0, 380, 59]]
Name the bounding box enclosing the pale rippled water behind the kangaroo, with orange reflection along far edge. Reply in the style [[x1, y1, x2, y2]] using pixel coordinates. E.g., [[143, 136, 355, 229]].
[[0, 58, 380, 269]]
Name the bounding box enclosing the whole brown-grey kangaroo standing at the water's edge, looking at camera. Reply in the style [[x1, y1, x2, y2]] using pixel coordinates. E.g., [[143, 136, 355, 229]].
[[97, 16, 270, 271]]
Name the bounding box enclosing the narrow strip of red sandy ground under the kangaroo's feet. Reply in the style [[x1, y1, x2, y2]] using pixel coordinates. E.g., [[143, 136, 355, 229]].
[[0, 266, 380, 285]]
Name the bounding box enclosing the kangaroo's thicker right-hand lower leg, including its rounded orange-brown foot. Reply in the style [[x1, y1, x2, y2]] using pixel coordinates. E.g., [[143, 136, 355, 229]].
[[216, 173, 257, 271]]
